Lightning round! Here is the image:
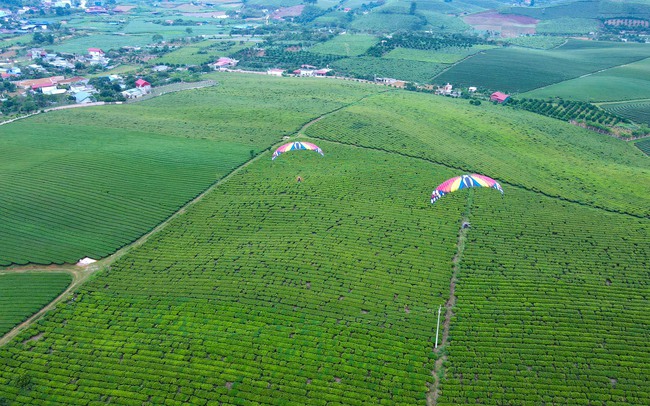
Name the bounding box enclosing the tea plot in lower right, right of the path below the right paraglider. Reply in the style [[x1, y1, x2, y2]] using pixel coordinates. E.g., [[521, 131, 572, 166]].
[[438, 188, 650, 405]]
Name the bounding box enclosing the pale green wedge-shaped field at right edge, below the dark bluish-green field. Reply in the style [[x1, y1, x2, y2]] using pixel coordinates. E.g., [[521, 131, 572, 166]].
[[522, 58, 650, 102]]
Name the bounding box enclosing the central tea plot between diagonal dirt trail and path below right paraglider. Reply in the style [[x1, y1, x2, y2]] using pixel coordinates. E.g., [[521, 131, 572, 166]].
[[0, 142, 464, 405]]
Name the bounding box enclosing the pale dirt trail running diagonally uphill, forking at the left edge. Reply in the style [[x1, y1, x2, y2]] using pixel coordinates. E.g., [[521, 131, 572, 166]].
[[0, 89, 394, 347]]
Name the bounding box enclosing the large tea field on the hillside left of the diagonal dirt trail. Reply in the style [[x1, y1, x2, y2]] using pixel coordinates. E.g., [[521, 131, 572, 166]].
[[0, 75, 380, 265]]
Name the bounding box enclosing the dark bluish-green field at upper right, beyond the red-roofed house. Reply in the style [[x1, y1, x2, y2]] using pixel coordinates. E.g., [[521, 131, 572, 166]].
[[436, 40, 650, 93]]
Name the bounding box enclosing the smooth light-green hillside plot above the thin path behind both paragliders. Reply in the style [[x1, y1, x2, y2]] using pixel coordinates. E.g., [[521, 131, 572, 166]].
[[307, 92, 650, 216]]
